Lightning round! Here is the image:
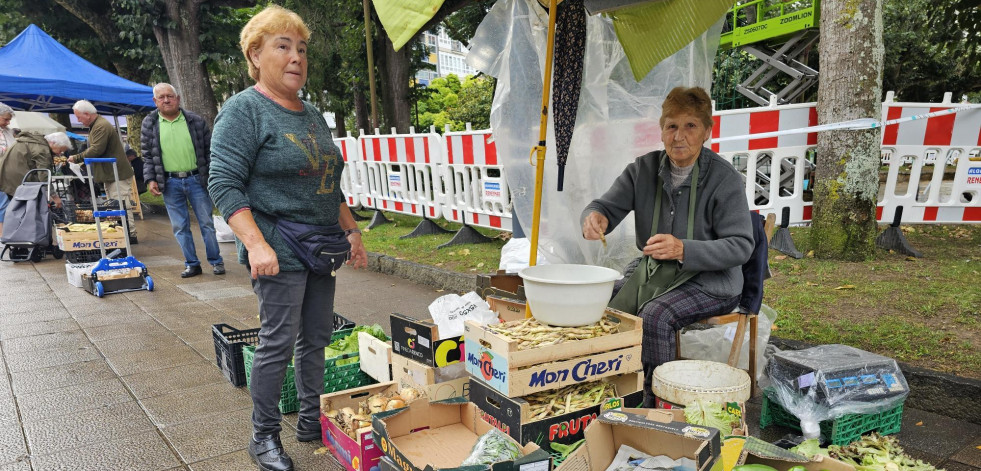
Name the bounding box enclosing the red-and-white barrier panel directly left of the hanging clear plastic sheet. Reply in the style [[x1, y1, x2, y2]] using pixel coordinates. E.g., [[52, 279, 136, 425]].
[[442, 129, 512, 231]]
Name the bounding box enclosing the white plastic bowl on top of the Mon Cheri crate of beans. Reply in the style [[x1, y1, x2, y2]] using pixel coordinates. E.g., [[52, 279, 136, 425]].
[[518, 264, 623, 327]]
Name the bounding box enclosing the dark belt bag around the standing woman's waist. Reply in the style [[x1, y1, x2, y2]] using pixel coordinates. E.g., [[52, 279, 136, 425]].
[[253, 210, 351, 276]]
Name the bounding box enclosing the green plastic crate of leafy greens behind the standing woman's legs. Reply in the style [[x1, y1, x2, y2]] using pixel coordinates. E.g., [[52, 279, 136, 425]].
[[242, 329, 377, 414]]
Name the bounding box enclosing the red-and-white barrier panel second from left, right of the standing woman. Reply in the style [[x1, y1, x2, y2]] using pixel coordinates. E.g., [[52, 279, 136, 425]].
[[359, 129, 442, 219]]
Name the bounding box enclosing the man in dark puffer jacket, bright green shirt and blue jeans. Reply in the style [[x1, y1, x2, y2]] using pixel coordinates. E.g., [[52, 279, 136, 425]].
[[140, 83, 225, 278]]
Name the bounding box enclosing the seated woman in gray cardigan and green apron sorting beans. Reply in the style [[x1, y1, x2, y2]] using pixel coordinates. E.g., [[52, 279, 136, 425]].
[[581, 87, 753, 404]]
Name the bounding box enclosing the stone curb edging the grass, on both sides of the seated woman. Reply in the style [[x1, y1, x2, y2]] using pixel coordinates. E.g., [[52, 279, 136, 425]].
[[368, 252, 981, 424]]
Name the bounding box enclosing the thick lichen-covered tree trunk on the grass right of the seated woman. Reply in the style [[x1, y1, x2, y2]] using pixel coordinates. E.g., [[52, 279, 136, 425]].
[[811, 0, 884, 261]]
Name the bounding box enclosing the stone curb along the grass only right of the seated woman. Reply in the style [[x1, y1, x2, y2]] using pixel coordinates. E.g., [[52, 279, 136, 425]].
[[770, 336, 981, 424]]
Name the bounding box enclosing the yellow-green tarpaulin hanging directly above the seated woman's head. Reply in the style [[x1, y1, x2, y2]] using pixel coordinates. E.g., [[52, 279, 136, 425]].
[[610, 0, 736, 81]]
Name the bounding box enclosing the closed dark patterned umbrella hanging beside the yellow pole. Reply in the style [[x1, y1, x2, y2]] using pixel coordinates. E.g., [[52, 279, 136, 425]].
[[552, 0, 586, 191]]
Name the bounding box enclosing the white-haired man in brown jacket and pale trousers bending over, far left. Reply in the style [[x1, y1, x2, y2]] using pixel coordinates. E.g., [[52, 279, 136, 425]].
[[68, 100, 138, 244]]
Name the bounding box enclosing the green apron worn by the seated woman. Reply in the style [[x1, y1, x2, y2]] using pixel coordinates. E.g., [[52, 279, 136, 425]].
[[609, 160, 699, 315]]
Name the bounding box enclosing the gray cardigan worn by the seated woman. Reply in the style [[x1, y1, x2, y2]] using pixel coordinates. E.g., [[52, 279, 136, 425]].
[[580, 148, 753, 297]]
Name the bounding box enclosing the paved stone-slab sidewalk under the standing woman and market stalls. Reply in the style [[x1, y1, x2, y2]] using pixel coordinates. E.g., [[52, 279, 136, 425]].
[[0, 214, 981, 471]]
